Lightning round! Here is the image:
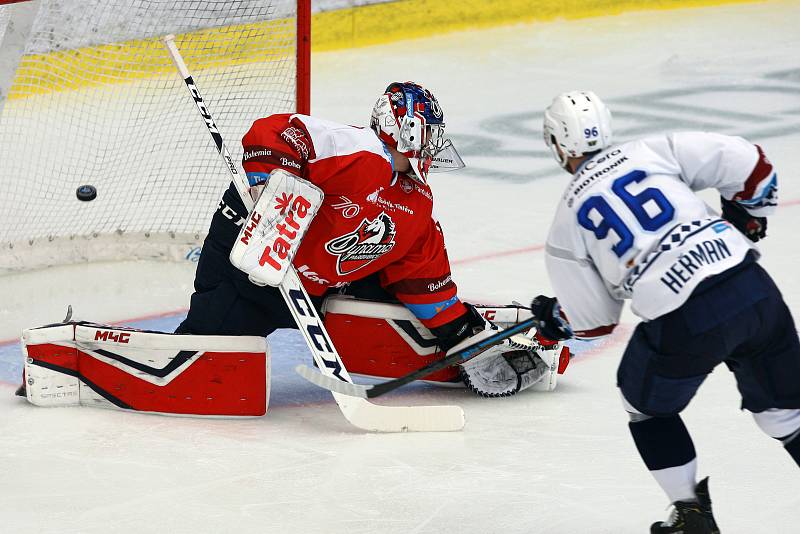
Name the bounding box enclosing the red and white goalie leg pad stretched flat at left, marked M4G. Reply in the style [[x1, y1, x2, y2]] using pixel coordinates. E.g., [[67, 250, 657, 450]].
[[22, 322, 270, 417]]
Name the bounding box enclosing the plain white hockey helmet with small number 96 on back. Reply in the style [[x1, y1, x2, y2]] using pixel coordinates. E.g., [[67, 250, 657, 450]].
[[544, 91, 612, 167]]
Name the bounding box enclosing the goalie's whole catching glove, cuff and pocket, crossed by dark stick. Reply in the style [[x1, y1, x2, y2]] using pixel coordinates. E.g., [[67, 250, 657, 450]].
[[448, 304, 569, 397]]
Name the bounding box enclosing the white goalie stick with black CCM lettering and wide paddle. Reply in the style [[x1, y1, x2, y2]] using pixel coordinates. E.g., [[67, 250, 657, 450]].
[[163, 35, 464, 432]]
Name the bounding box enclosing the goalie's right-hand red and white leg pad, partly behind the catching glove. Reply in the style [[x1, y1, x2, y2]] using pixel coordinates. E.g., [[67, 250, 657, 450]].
[[322, 295, 570, 391]]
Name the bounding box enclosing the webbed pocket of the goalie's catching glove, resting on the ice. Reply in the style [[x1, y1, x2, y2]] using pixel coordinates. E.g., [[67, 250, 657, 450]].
[[460, 340, 550, 397]]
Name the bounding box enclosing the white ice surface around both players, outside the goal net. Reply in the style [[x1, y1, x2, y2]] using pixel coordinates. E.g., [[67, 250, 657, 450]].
[[0, 1, 800, 534]]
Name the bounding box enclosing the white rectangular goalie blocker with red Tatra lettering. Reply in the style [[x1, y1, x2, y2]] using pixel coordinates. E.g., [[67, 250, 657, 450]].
[[230, 169, 324, 286]]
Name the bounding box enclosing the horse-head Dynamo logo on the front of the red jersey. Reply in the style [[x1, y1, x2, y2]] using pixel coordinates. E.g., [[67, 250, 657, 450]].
[[325, 212, 395, 275]]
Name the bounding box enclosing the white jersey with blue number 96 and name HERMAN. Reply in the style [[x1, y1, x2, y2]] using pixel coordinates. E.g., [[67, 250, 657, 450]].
[[546, 132, 777, 337]]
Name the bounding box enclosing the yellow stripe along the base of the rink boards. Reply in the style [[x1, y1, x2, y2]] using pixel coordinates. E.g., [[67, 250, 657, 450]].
[[8, 0, 754, 100]]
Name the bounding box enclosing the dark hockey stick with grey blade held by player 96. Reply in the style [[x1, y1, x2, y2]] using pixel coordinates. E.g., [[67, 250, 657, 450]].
[[295, 317, 536, 399]]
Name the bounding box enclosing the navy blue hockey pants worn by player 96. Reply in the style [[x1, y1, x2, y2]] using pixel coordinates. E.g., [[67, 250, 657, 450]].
[[617, 259, 800, 416]]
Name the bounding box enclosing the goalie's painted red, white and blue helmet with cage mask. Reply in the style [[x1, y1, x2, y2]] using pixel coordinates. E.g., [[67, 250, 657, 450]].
[[370, 82, 464, 183]]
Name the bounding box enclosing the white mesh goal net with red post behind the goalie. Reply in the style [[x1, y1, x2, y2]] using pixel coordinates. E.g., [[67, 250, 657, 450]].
[[0, 0, 310, 274]]
